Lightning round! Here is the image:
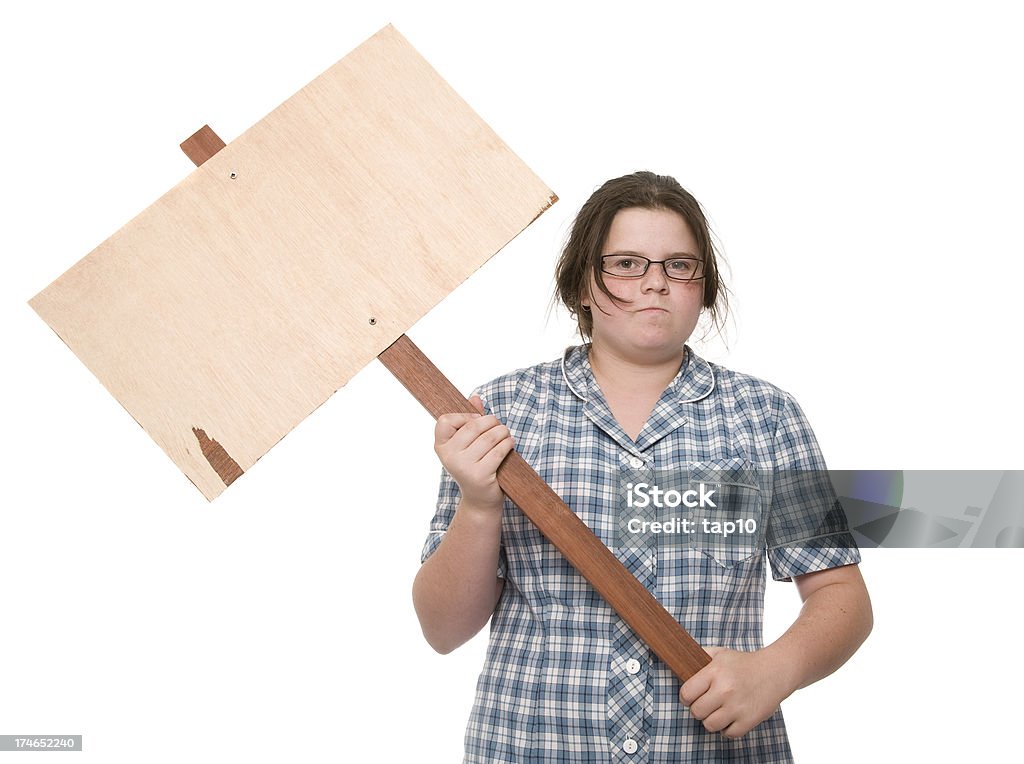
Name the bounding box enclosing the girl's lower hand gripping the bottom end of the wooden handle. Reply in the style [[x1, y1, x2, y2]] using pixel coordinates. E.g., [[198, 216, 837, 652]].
[[679, 647, 793, 737]]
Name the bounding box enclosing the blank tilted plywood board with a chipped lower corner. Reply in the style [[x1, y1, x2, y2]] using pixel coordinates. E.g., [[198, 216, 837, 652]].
[[31, 27, 555, 499]]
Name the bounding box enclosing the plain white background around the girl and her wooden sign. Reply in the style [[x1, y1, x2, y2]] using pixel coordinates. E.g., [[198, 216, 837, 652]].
[[0, 0, 1024, 763]]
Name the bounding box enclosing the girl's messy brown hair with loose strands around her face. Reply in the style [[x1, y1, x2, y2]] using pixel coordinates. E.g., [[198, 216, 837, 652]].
[[555, 171, 728, 339]]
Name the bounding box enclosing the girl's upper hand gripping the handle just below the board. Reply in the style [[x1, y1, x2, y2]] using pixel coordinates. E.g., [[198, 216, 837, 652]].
[[434, 395, 514, 512]]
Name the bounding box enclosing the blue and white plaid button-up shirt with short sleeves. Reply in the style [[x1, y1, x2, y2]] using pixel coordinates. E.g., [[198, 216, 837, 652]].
[[423, 345, 860, 764]]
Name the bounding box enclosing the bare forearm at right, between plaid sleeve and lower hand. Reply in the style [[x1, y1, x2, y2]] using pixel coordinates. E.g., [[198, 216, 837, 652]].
[[763, 565, 873, 695]]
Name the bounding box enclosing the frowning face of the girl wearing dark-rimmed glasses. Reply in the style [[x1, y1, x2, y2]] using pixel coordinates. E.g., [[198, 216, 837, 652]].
[[582, 207, 703, 364]]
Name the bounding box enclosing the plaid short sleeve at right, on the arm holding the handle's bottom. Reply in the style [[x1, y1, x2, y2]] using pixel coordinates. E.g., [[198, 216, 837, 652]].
[[766, 394, 860, 581]]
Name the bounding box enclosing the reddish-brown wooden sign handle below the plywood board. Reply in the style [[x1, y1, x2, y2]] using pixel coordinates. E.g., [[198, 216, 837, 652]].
[[379, 335, 711, 681]]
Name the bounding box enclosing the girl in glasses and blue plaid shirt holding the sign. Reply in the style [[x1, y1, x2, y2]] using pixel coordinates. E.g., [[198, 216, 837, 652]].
[[413, 172, 871, 762]]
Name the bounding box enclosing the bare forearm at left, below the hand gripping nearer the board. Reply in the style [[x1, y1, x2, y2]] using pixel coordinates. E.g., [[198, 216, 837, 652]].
[[413, 504, 503, 653]]
